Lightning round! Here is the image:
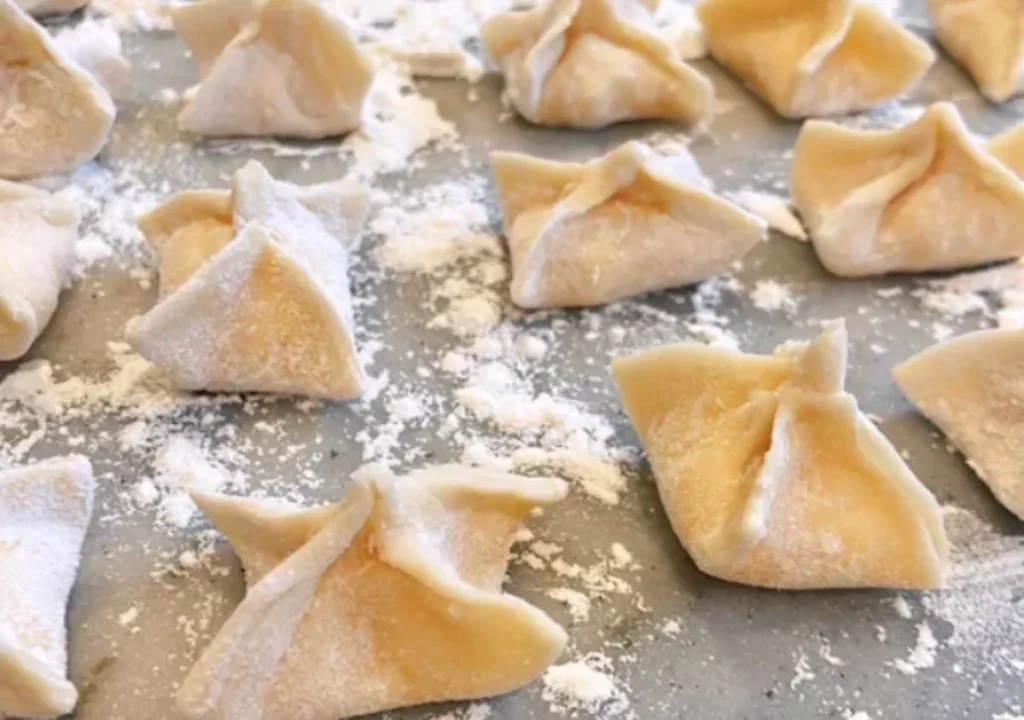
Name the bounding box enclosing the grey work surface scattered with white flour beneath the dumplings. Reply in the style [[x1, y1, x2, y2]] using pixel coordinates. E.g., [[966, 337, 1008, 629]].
[[0, 2, 1024, 720]]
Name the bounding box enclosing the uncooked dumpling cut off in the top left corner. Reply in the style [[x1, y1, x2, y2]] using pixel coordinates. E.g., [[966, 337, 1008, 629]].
[[0, 0, 122, 179]]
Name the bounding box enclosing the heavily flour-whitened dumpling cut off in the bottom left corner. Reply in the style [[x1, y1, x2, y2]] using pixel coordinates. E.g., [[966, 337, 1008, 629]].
[[0, 457, 93, 718]]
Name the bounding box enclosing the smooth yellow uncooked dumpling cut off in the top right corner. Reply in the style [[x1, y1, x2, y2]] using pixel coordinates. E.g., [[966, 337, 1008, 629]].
[[928, 0, 1024, 102]]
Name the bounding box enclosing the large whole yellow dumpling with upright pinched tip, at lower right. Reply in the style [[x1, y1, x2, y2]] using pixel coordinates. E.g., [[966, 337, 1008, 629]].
[[612, 323, 948, 590]]
